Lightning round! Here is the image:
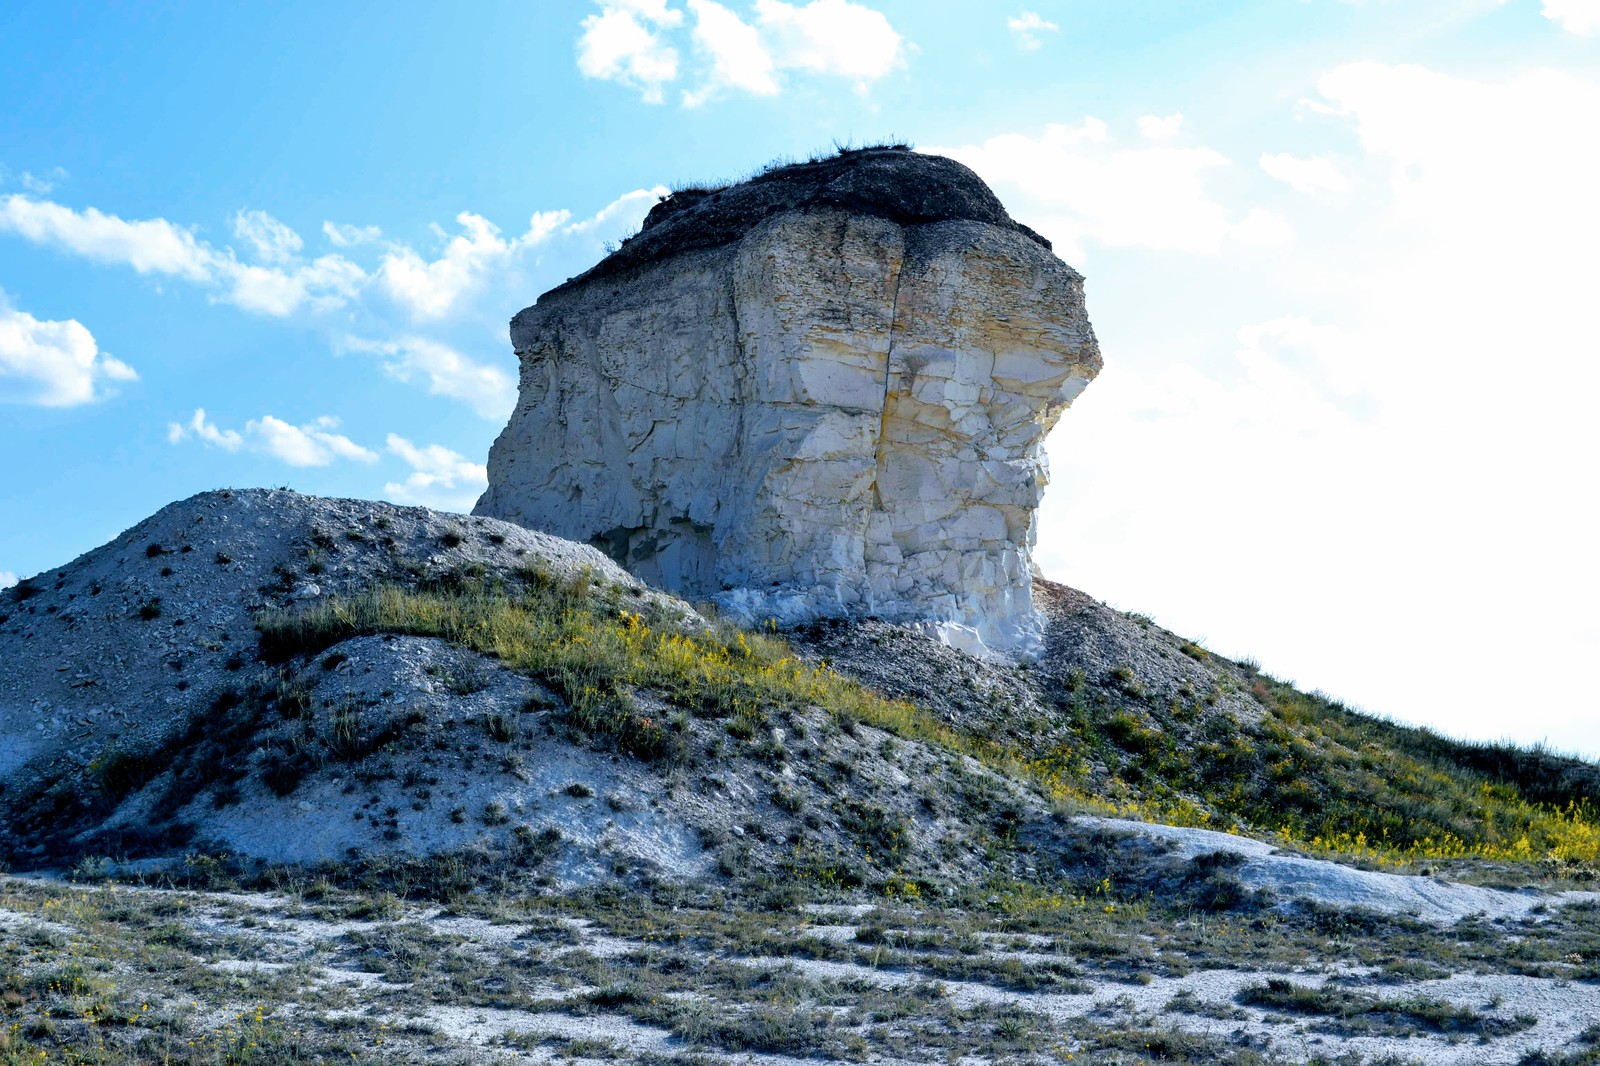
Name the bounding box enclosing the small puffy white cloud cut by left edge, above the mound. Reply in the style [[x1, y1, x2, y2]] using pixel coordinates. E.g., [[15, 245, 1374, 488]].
[[0, 293, 139, 407]]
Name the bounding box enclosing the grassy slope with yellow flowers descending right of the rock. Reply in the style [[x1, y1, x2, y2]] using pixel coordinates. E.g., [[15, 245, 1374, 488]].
[[1034, 667, 1600, 877]]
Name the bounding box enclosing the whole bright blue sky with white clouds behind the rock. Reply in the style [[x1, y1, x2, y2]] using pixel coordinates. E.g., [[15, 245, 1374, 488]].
[[0, 0, 1600, 745]]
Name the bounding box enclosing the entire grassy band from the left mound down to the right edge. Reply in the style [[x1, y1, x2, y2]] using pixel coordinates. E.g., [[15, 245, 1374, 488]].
[[258, 571, 1600, 877]]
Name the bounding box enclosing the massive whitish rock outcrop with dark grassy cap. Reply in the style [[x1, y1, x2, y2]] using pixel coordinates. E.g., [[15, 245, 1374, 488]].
[[477, 149, 1101, 650]]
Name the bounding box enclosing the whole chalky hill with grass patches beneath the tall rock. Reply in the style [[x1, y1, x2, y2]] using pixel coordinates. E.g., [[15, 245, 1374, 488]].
[[0, 490, 1600, 906]]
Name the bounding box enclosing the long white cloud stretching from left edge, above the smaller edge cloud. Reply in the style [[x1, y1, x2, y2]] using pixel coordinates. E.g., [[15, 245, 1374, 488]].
[[0, 194, 366, 317]]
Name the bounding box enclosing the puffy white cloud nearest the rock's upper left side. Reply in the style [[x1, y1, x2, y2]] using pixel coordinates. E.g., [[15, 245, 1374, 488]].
[[378, 211, 570, 319]]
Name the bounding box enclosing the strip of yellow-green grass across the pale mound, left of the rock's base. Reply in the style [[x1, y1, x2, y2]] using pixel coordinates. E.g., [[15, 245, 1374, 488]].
[[256, 570, 1016, 770]]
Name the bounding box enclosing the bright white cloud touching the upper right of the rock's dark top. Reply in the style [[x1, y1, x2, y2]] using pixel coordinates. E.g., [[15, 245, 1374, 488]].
[[928, 118, 1291, 259]]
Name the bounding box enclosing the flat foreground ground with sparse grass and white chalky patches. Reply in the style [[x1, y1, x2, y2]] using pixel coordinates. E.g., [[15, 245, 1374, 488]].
[[0, 877, 1600, 1064]]
